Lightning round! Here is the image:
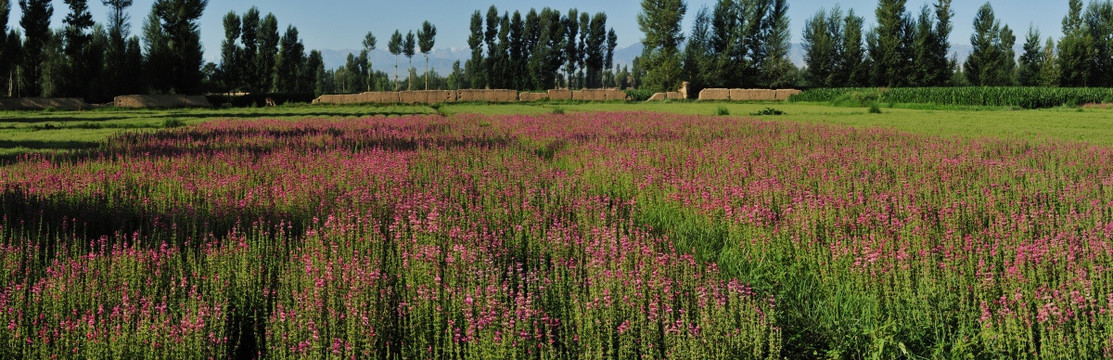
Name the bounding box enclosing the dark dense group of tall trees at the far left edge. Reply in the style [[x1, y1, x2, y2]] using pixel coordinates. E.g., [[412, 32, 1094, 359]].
[[0, 0, 207, 101]]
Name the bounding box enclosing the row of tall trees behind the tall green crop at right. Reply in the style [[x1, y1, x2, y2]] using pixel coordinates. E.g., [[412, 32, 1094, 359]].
[[804, 0, 1113, 87]]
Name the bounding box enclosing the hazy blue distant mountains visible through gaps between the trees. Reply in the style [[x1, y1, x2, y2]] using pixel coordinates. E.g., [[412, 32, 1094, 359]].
[[321, 42, 983, 78]]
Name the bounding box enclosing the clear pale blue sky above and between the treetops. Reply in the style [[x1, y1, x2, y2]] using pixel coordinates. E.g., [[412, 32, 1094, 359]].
[[9, 0, 1067, 59]]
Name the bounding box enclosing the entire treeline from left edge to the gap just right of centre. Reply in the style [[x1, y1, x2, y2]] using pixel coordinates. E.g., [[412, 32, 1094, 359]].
[[0, 0, 631, 101]]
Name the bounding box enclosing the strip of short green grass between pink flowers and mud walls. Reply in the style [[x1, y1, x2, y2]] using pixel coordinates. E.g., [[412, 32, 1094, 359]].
[[0, 103, 1113, 158]]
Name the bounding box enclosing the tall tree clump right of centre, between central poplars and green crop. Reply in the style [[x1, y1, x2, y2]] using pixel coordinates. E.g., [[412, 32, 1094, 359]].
[[636, 0, 797, 93]]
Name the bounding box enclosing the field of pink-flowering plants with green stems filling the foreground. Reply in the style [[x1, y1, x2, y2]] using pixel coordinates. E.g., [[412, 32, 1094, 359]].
[[0, 113, 1113, 359]]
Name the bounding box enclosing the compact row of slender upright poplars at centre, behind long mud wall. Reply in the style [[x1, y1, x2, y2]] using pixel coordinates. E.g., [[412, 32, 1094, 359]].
[[462, 6, 618, 90]]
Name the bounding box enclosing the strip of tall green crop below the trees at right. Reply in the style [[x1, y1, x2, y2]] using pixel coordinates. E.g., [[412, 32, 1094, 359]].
[[789, 87, 1113, 109]]
